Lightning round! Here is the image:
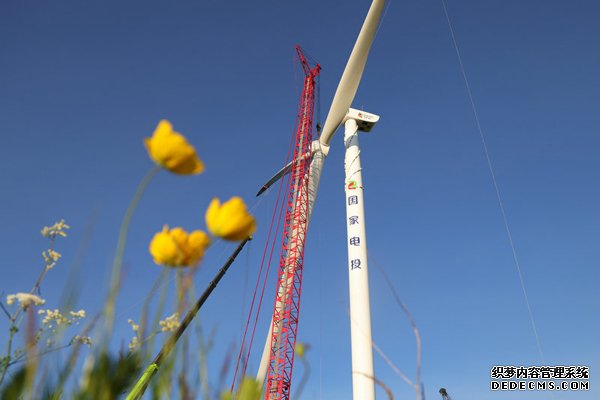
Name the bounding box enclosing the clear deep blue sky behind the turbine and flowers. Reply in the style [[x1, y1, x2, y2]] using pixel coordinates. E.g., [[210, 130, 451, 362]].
[[0, 0, 600, 400]]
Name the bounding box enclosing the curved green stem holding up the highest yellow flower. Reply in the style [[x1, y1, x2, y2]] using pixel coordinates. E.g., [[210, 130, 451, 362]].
[[104, 165, 161, 344]]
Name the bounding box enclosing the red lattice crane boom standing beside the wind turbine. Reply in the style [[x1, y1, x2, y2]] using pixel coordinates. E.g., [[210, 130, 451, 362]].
[[265, 46, 321, 400]]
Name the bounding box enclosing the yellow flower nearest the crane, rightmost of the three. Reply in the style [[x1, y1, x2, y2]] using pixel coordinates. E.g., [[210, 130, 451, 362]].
[[206, 197, 256, 241]]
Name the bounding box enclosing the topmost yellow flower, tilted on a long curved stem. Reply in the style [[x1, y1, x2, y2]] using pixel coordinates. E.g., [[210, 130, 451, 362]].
[[144, 119, 204, 175]]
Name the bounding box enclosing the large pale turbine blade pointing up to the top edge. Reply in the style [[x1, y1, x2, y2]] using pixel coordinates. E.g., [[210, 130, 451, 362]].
[[319, 0, 385, 146]]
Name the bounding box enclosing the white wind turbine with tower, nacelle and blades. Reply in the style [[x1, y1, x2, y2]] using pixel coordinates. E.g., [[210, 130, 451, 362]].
[[257, 0, 385, 400]]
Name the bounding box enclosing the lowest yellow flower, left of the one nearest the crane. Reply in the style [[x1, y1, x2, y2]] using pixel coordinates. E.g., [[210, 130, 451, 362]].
[[150, 225, 210, 267]]
